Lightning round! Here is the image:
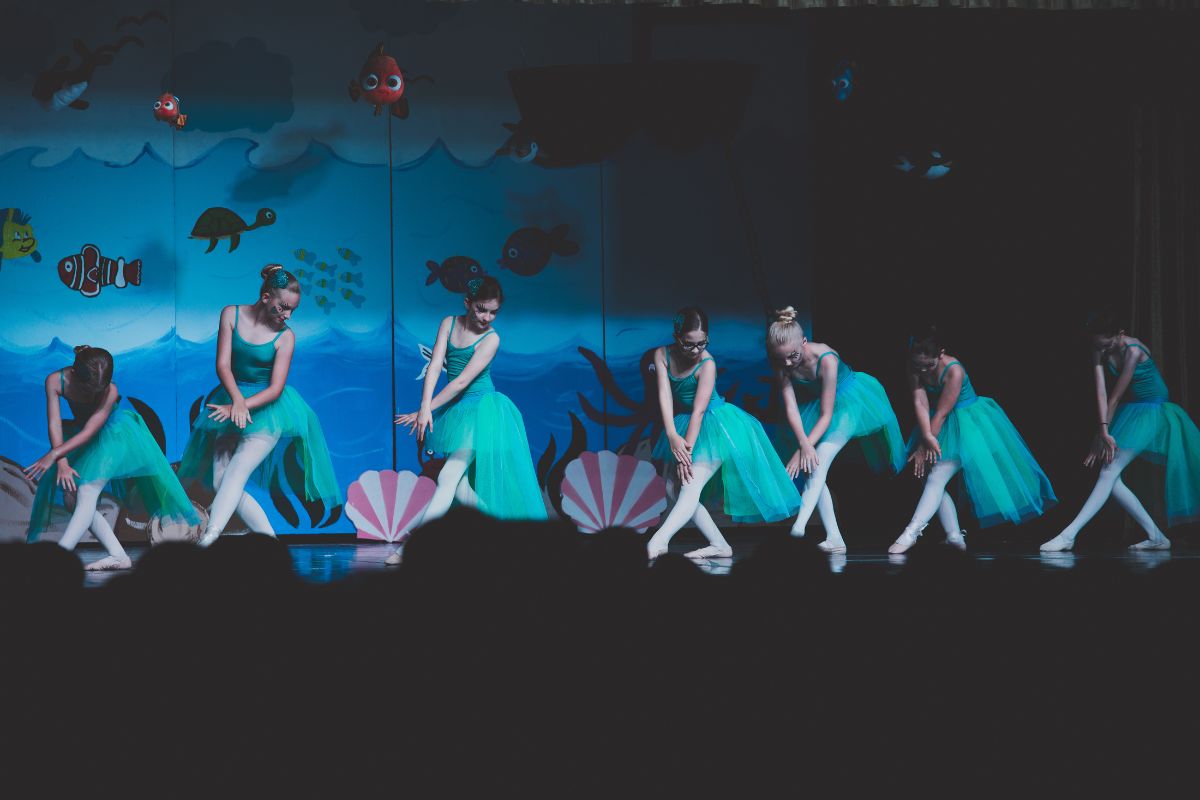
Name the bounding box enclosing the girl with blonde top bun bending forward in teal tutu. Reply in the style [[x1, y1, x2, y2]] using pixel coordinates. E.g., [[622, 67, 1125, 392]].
[[767, 306, 905, 553]]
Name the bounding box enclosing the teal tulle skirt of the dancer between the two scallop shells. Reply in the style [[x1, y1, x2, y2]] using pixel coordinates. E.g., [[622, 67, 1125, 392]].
[[425, 391, 546, 519]]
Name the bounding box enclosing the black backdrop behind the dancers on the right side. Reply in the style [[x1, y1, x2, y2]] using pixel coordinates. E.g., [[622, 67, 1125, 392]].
[[809, 10, 1200, 547]]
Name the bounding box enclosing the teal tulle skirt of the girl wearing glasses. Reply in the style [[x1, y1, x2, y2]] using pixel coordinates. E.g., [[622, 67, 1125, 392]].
[[653, 403, 800, 522]]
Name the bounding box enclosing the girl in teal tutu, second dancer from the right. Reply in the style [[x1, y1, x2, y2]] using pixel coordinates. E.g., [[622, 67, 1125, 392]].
[[888, 326, 1057, 553]]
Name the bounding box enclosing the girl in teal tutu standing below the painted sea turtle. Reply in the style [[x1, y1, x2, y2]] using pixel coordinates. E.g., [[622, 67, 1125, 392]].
[[179, 264, 342, 547]]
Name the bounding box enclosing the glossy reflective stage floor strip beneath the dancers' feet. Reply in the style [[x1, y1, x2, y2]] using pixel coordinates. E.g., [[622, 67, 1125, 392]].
[[78, 531, 1200, 587]]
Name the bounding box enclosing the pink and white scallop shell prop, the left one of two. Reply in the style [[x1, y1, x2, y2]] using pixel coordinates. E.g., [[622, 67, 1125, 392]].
[[346, 469, 437, 542]]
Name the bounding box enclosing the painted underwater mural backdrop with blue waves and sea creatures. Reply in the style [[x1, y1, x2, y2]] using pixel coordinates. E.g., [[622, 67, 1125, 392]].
[[0, 0, 811, 535]]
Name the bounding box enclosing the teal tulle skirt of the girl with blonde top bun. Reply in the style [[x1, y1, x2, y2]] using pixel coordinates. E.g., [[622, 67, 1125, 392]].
[[773, 372, 905, 480]]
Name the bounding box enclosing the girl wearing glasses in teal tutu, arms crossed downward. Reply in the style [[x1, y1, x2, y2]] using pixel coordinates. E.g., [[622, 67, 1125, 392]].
[[647, 307, 800, 559]]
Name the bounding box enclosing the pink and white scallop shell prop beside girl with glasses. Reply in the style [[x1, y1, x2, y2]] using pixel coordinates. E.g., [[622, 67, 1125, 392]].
[[563, 450, 667, 534]]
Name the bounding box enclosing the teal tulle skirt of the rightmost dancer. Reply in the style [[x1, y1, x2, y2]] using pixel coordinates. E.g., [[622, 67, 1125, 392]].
[[1109, 402, 1200, 525]]
